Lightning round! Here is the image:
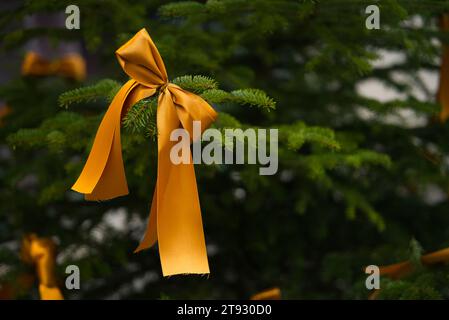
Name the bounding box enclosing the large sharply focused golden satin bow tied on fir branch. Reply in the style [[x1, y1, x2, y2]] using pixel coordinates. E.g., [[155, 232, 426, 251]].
[[72, 29, 217, 276]]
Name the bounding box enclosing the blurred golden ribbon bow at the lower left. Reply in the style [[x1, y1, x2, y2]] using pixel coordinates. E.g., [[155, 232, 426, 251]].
[[21, 234, 64, 300]]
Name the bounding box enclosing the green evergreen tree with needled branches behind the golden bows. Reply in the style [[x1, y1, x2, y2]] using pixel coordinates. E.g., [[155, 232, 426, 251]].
[[0, 0, 449, 299]]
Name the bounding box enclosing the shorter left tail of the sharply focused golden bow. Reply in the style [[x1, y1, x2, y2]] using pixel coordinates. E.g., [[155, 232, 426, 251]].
[[72, 80, 136, 200]]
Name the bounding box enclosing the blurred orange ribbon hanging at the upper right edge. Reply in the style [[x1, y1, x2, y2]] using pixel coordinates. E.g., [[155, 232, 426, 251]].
[[438, 14, 449, 122]]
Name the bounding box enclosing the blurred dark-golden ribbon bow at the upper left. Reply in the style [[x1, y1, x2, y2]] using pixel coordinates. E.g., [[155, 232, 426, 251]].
[[22, 52, 86, 81]]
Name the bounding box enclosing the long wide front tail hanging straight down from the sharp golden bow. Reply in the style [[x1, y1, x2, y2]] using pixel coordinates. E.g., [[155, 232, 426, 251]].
[[156, 90, 209, 276]]
